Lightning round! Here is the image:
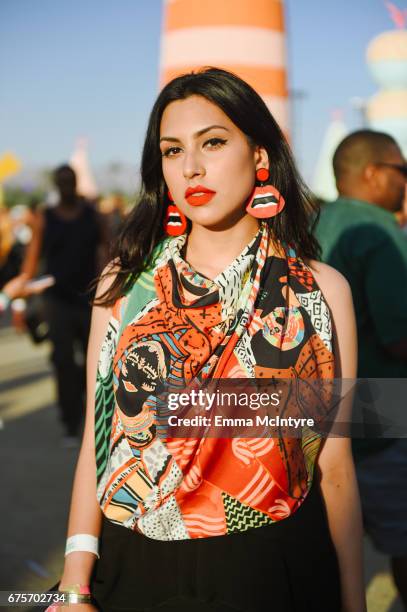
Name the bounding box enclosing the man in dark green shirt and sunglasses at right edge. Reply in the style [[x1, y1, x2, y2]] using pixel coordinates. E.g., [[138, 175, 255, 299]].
[[317, 130, 407, 607]]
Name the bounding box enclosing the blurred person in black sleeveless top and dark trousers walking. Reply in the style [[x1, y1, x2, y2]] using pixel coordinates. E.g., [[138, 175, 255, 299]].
[[22, 165, 107, 447]]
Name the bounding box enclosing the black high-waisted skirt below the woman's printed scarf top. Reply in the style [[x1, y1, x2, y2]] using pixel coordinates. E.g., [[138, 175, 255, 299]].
[[91, 483, 341, 612]]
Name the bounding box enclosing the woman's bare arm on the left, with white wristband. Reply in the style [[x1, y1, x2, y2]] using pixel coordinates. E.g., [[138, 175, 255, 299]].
[[60, 266, 117, 589]]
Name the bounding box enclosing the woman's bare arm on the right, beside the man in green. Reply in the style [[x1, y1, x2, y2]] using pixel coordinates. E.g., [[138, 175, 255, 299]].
[[312, 262, 366, 612]]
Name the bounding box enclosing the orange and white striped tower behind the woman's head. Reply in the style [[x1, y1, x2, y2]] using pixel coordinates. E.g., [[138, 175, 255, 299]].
[[160, 0, 290, 134]]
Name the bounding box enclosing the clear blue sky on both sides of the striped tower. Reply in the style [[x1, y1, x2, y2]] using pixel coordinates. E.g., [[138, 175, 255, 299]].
[[0, 0, 396, 178]]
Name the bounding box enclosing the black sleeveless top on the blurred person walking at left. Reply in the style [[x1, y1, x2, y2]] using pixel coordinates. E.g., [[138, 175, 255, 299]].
[[42, 201, 101, 305]]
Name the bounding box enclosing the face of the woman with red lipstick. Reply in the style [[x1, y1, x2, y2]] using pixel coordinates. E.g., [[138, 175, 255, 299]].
[[160, 95, 268, 227]]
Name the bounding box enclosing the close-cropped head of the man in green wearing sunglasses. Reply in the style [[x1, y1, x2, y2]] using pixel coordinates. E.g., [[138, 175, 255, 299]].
[[333, 130, 405, 211]]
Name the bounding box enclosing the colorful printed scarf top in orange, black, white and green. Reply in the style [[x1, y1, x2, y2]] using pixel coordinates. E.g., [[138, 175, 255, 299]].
[[95, 223, 334, 540]]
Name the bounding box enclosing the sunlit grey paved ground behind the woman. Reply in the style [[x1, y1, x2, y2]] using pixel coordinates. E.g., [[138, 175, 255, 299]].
[[0, 320, 402, 612]]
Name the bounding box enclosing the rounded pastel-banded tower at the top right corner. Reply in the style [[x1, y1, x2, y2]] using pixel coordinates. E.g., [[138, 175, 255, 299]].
[[366, 2, 407, 156]]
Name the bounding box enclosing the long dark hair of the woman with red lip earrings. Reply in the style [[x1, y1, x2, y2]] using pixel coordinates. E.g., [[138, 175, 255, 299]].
[[95, 68, 320, 306]]
